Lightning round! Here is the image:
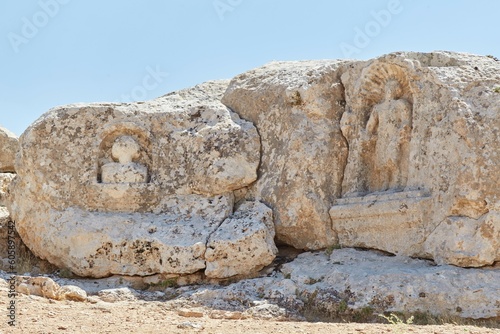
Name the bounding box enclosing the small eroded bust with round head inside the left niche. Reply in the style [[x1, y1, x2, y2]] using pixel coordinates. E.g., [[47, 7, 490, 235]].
[[102, 136, 148, 183]]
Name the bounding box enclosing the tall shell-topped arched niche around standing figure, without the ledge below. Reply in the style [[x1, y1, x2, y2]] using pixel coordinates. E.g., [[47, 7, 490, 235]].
[[340, 65, 413, 195]]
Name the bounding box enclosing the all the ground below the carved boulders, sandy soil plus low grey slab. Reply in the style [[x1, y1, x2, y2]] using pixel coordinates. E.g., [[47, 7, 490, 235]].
[[0, 248, 500, 334]]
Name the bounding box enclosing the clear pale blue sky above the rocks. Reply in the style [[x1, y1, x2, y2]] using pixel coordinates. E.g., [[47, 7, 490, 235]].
[[0, 0, 500, 135]]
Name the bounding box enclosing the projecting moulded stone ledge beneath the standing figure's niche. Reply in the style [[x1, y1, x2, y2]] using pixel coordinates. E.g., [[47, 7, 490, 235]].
[[330, 191, 431, 255]]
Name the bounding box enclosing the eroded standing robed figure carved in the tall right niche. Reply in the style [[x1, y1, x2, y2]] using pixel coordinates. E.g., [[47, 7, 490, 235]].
[[366, 80, 412, 191]]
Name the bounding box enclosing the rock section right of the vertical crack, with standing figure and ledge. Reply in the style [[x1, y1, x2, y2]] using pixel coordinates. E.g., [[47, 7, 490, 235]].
[[330, 52, 500, 266]]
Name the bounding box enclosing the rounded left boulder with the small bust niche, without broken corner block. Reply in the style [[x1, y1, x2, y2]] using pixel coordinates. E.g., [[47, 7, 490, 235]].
[[4, 82, 278, 277]]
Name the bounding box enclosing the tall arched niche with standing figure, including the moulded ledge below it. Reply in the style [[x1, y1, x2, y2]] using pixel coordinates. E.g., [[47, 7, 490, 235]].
[[329, 62, 431, 255]]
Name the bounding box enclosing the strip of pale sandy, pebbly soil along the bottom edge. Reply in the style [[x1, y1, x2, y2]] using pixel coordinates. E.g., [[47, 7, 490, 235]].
[[0, 292, 500, 334]]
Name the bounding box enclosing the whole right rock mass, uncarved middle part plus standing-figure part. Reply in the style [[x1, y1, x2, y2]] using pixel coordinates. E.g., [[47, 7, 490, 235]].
[[222, 52, 500, 266]]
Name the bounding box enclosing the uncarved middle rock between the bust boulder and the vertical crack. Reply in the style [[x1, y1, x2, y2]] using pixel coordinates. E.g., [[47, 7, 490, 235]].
[[222, 61, 347, 249]]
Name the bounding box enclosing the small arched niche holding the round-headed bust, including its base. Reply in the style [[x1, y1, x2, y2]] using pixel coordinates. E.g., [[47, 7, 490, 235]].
[[84, 122, 157, 212]]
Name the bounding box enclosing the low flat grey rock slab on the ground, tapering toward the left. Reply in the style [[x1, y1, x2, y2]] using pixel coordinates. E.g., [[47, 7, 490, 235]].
[[176, 249, 500, 320]]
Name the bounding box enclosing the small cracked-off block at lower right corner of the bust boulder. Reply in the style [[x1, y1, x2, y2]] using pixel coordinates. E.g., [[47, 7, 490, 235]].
[[205, 202, 278, 278]]
